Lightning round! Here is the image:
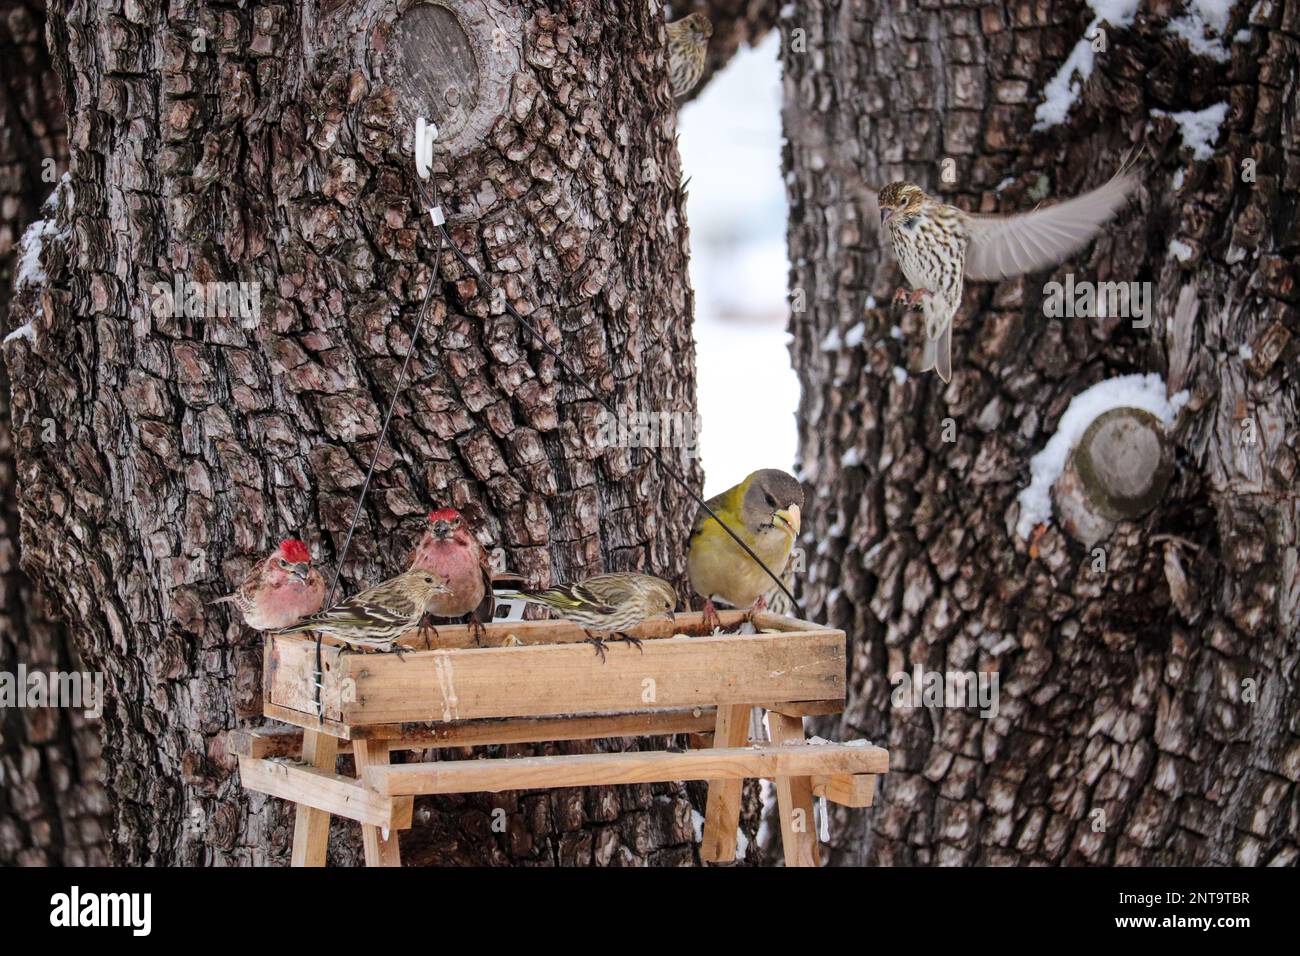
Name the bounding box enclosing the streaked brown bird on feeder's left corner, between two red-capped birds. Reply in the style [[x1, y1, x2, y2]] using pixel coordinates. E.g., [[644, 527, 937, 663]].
[[276, 568, 449, 652]]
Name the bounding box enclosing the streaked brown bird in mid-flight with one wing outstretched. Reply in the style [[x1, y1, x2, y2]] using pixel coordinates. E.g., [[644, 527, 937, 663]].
[[876, 157, 1138, 381]]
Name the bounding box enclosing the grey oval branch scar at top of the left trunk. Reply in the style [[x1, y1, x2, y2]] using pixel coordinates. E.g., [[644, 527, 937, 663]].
[[385, 0, 523, 155]]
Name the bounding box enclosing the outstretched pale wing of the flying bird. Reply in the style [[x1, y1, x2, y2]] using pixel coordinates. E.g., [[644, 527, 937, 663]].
[[966, 172, 1138, 281]]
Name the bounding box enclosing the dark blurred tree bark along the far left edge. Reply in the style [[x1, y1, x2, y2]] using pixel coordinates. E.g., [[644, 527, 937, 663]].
[[0, 0, 107, 865]]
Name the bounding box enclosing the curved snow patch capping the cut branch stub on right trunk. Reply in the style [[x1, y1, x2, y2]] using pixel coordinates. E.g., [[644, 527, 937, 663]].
[[1015, 372, 1188, 538]]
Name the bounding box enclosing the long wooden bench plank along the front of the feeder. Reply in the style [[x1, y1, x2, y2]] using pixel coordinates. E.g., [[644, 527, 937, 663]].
[[366, 744, 889, 801]]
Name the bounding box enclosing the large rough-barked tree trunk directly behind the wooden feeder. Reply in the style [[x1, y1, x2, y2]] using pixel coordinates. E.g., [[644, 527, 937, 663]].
[[5, 0, 733, 865]]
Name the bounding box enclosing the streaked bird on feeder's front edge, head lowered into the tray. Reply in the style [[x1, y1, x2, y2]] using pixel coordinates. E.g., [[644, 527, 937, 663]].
[[501, 571, 677, 661]]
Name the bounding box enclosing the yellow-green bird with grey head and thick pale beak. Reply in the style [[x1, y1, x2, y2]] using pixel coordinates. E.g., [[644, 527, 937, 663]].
[[686, 468, 803, 630]]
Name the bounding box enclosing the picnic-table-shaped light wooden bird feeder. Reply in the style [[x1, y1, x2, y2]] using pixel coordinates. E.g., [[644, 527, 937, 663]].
[[230, 611, 889, 866]]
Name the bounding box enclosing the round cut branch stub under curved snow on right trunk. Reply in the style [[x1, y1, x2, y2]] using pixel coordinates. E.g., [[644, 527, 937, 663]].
[[1053, 407, 1174, 546]]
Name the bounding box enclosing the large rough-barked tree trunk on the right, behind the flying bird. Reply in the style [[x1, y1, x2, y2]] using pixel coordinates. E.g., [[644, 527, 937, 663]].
[[783, 0, 1300, 865]]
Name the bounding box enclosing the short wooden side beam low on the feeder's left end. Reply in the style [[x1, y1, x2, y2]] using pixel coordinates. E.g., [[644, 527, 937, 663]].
[[239, 757, 415, 832]]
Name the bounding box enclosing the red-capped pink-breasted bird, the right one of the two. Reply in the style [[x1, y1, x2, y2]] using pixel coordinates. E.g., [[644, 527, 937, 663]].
[[411, 507, 495, 644]]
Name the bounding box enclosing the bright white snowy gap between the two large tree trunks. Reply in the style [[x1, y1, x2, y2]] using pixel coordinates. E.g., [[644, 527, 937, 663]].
[[677, 31, 800, 496]]
